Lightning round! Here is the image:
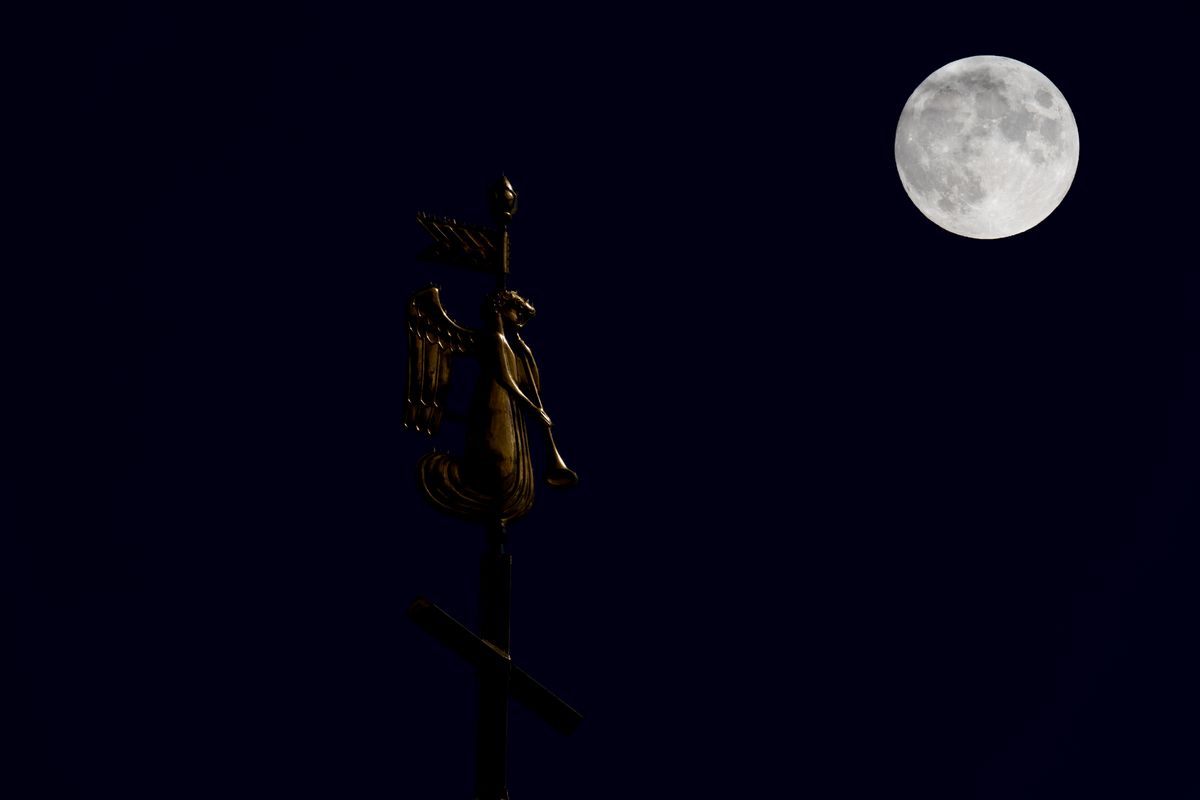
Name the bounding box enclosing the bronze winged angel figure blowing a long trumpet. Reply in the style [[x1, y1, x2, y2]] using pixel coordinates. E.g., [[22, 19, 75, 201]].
[[404, 287, 578, 523]]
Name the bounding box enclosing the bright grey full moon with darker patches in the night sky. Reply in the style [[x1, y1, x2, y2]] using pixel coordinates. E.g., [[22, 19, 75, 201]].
[[895, 55, 1079, 239]]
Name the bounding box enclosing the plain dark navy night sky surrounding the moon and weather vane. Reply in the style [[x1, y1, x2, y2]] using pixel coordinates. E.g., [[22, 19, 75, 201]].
[[0, 4, 1200, 800]]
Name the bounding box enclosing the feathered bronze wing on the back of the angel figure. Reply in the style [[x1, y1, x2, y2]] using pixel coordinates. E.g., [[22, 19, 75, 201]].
[[404, 285, 475, 434]]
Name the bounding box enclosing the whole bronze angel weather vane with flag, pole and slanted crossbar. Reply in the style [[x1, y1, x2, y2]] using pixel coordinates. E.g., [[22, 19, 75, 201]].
[[404, 176, 582, 800]]
